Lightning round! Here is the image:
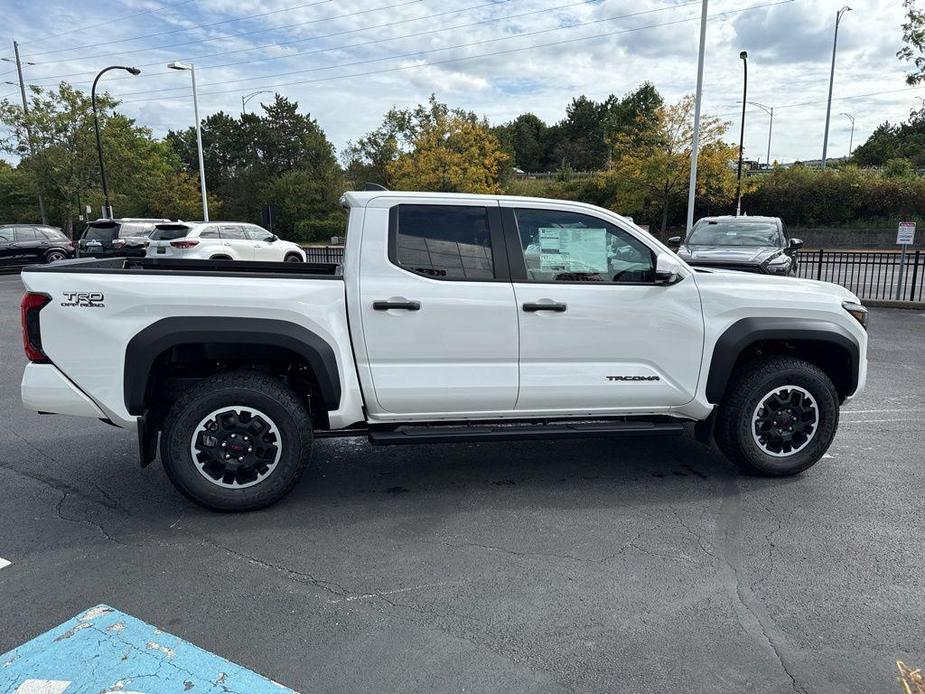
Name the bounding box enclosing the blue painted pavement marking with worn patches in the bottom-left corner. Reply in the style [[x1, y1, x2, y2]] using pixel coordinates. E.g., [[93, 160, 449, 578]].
[[0, 605, 294, 694]]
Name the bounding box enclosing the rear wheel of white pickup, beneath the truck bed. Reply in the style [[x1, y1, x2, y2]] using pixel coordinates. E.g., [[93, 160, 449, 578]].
[[161, 371, 312, 511]]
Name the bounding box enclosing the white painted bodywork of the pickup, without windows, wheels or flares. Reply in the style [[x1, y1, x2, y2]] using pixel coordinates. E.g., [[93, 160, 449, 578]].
[[22, 192, 867, 438]]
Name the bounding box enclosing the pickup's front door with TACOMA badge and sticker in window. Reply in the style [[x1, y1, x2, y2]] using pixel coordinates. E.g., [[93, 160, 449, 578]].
[[502, 201, 703, 414]]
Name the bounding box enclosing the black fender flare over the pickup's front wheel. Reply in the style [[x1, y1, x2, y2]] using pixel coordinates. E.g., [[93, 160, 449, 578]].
[[706, 317, 861, 403]]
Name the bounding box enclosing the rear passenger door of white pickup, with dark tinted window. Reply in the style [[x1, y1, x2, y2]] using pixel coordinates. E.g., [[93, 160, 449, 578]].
[[357, 198, 517, 418]]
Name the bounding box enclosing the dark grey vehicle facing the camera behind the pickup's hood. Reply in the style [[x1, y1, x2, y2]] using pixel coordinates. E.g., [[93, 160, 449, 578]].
[[668, 216, 803, 275]]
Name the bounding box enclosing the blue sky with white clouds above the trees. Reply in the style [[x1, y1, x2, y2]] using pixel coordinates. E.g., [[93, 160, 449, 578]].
[[0, 0, 925, 167]]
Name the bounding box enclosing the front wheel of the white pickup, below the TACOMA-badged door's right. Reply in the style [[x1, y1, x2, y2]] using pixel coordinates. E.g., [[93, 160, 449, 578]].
[[715, 357, 839, 476]]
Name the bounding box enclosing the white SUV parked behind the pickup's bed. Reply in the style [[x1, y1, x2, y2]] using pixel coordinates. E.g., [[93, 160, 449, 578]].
[[147, 222, 305, 263]]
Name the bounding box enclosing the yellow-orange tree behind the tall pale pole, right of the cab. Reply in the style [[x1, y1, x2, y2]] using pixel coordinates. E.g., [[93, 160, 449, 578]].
[[607, 96, 736, 231]]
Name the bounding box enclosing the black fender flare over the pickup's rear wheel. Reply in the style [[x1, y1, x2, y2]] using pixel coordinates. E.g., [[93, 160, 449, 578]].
[[123, 316, 341, 416]]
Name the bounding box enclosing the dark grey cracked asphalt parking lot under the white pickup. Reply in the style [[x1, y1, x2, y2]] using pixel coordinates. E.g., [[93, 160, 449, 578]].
[[0, 276, 925, 693]]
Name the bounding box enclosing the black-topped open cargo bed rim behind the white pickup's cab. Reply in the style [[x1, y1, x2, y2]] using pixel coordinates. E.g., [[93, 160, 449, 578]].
[[22, 258, 342, 279]]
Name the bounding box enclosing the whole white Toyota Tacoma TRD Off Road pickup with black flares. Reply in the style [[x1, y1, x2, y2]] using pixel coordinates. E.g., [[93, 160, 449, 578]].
[[22, 191, 867, 510]]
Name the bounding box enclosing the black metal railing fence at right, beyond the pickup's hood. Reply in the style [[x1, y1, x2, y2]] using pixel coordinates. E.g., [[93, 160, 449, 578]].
[[797, 249, 925, 301]]
